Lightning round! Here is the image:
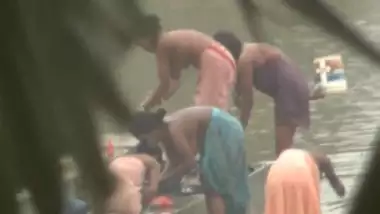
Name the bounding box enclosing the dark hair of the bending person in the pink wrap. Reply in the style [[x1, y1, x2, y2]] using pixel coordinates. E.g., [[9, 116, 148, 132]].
[[132, 14, 162, 39]]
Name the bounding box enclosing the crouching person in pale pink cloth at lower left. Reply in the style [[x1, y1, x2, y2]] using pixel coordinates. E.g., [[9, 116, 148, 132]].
[[108, 142, 162, 214]]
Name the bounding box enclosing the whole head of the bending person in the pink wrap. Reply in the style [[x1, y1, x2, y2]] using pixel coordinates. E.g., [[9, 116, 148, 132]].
[[133, 15, 162, 52]]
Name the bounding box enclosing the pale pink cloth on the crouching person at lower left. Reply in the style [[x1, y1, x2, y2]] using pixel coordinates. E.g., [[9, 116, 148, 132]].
[[108, 157, 145, 214]]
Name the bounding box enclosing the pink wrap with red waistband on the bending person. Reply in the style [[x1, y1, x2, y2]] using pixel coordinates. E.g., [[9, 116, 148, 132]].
[[195, 44, 236, 110]]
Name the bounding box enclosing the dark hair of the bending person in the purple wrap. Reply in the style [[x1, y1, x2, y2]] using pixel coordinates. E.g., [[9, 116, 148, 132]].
[[213, 30, 243, 61]]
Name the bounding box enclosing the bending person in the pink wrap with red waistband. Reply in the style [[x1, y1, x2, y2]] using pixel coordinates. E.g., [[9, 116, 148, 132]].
[[135, 16, 242, 110]]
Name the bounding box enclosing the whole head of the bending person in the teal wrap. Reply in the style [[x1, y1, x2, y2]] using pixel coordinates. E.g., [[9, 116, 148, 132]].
[[129, 108, 166, 141]]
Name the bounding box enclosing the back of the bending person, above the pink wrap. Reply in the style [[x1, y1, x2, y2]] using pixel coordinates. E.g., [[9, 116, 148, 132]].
[[158, 29, 215, 69]]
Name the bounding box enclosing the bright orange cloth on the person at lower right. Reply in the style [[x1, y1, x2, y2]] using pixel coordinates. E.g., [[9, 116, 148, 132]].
[[265, 149, 321, 214]]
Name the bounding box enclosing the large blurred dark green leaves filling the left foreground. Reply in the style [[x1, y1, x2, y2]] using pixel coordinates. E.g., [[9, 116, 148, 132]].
[[0, 0, 152, 214]]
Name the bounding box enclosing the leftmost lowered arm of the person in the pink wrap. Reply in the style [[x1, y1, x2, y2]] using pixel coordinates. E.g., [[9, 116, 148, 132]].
[[143, 47, 170, 110]]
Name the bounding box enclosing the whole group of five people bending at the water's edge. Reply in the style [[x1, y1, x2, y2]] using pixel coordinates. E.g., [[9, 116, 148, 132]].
[[105, 16, 345, 214]]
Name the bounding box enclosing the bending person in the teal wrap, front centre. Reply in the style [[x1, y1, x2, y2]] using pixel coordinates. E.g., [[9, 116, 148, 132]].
[[130, 106, 250, 214]]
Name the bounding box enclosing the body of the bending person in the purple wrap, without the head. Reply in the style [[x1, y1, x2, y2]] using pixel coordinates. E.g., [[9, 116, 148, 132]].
[[214, 31, 323, 156]]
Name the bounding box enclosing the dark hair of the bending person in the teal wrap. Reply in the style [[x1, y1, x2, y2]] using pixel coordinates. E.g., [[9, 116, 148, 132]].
[[129, 108, 166, 138]]
